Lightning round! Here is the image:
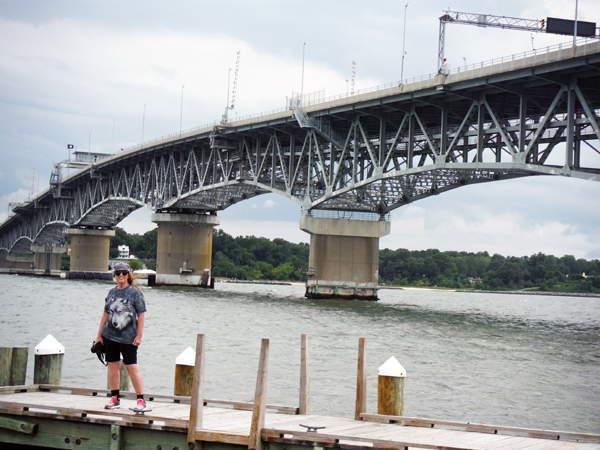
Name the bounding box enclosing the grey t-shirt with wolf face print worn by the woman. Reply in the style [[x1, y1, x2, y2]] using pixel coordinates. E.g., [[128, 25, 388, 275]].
[[102, 286, 146, 344]]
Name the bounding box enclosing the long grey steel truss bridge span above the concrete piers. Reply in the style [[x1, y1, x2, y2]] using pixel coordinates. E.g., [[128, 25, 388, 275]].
[[0, 40, 600, 254]]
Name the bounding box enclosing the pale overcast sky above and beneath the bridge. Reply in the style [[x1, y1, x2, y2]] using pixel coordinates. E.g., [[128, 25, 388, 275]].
[[0, 0, 600, 259]]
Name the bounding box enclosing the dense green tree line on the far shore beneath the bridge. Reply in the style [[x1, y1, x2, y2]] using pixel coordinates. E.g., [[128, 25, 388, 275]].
[[102, 227, 600, 293]]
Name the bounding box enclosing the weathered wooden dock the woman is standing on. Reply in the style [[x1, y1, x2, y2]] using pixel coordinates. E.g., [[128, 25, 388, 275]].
[[0, 385, 600, 450]]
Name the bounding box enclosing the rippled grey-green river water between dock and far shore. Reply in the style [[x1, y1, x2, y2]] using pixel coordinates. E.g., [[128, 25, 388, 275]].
[[0, 275, 600, 433]]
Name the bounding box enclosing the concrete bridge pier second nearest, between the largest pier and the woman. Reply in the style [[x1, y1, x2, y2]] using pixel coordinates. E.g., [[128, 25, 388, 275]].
[[152, 213, 221, 287]]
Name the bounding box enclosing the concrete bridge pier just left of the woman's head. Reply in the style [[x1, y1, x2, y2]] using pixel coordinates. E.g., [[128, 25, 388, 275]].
[[67, 228, 115, 279]]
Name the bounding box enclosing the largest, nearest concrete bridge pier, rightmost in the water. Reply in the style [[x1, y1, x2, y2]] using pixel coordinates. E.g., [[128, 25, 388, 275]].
[[300, 216, 390, 300]]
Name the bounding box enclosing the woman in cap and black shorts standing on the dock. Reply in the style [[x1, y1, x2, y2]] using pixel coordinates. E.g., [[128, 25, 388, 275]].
[[94, 262, 146, 411]]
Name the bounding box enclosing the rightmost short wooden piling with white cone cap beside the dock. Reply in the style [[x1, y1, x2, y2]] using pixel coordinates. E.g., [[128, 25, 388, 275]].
[[377, 356, 406, 416]]
